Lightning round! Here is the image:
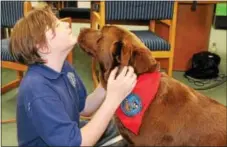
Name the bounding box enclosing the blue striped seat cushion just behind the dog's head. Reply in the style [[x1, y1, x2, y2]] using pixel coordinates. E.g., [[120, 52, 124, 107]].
[[132, 30, 170, 51]]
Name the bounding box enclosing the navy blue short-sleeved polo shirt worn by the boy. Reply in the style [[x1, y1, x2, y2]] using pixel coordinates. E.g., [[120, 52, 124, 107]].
[[17, 62, 87, 147]]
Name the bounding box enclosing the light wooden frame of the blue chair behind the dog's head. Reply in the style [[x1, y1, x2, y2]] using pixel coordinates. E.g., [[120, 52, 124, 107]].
[[91, 1, 178, 87]]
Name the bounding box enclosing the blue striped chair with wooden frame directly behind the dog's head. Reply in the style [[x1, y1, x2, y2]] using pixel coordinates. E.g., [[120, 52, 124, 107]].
[[91, 1, 178, 86]]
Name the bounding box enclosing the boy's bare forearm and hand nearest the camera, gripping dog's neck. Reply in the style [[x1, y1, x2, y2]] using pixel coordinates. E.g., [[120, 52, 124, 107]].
[[81, 67, 136, 146]]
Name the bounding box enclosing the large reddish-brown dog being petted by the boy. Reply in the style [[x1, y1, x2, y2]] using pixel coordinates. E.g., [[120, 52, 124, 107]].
[[78, 26, 227, 146]]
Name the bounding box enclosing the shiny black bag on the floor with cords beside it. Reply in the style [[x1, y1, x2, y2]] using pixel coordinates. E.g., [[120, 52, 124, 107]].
[[184, 51, 221, 79]]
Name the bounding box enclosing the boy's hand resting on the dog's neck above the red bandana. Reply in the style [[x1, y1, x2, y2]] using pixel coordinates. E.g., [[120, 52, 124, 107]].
[[106, 67, 137, 107]]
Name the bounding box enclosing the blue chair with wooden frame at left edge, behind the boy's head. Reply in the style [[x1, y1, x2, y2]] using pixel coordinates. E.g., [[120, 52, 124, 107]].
[[1, 1, 32, 94]]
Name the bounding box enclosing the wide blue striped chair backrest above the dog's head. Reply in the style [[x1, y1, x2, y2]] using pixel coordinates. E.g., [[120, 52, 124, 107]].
[[105, 1, 174, 20]]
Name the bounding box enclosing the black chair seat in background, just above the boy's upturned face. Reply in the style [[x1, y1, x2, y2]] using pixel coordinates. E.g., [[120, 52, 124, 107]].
[[59, 7, 90, 19]]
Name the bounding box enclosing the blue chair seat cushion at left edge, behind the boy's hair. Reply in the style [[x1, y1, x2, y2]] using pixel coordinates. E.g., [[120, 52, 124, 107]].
[[1, 39, 15, 62]]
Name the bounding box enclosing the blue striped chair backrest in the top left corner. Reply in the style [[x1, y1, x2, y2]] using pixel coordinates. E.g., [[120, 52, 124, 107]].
[[1, 1, 24, 28]]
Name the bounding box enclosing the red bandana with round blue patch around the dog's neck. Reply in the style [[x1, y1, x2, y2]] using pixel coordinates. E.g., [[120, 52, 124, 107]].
[[116, 72, 161, 135]]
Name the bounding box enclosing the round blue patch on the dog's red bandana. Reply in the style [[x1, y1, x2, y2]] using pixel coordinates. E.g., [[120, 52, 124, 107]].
[[121, 94, 142, 117]]
